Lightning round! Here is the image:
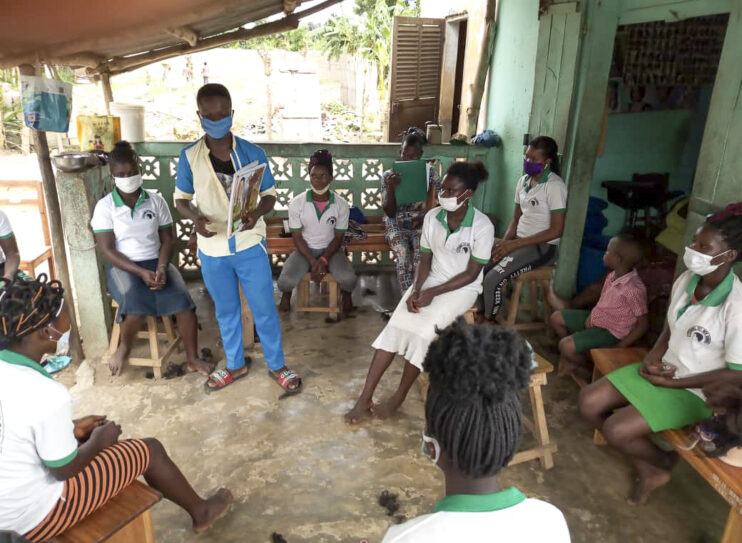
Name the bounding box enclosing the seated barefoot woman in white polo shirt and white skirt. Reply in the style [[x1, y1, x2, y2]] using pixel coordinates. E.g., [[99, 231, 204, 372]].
[[345, 162, 495, 424]]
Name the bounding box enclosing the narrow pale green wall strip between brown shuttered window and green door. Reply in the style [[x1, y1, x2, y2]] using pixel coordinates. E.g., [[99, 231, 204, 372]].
[[486, 0, 538, 236]]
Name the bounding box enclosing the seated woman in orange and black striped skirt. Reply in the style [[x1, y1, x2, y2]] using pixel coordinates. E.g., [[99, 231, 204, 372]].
[[0, 274, 233, 542]]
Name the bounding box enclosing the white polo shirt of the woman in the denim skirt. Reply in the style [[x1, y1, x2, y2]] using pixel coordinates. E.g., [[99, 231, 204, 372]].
[[90, 189, 173, 262]]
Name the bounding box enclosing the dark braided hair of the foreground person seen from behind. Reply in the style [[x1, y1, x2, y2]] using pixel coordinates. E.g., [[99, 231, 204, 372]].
[[424, 318, 531, 478]]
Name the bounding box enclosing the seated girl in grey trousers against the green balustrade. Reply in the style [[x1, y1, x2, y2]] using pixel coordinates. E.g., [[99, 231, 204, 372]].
[[278, 149, 357, 314]]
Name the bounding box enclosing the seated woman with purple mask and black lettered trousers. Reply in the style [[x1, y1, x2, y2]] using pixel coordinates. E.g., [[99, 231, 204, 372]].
[[481, 136, 567, 320]]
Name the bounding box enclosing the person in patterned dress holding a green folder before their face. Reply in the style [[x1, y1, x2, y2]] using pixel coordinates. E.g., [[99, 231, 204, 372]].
[[381, 127, 440, 292]]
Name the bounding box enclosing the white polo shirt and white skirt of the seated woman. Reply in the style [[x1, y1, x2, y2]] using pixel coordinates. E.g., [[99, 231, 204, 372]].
[[373, 205, 495, 370]]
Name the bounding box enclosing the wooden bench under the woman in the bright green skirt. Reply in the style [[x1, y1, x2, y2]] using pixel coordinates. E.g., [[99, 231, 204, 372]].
[[590, 347, 742, 543]]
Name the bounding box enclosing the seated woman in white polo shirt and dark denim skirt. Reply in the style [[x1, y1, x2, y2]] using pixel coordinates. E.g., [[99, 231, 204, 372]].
[[90, 141, 214, 375]]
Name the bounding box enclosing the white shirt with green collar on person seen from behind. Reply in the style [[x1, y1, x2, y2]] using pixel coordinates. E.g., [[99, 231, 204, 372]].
[[382, 487, 570, 543]]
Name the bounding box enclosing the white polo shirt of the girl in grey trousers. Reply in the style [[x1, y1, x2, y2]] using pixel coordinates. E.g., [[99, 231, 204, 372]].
[[289, 189, 350, 249]]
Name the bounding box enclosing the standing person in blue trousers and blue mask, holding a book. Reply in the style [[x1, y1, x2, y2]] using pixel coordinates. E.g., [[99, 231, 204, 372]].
[[174, 83, 302, 393]]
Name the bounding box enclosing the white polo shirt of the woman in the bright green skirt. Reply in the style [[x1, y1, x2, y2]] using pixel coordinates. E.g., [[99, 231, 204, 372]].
[[663, 271, 742, 399]]
